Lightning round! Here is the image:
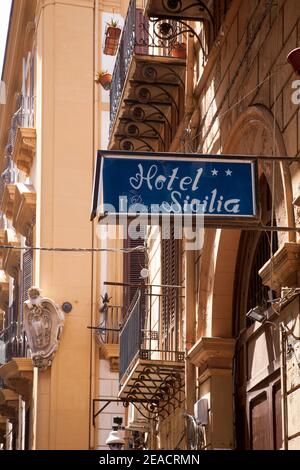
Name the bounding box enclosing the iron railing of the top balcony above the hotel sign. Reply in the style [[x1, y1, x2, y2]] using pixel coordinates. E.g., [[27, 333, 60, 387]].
[[110, 0, 189, 132]]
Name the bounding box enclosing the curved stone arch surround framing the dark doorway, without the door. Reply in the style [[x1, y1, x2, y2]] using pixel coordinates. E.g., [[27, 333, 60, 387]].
[[198, 105, 295, 337]]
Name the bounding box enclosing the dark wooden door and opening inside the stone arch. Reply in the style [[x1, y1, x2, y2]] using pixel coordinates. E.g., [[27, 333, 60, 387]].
[[233, 175, 282, 450]]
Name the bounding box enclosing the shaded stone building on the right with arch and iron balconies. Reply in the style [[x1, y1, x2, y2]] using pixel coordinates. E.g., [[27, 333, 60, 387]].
[[96, 0, 300, 449]]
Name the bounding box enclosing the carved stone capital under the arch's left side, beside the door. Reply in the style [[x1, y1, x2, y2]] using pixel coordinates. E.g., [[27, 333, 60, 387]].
[[187, 338, 235, 378]]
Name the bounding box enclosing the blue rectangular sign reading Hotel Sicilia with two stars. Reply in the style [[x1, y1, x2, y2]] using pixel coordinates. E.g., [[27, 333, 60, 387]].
[[92, 151, 257, 220]]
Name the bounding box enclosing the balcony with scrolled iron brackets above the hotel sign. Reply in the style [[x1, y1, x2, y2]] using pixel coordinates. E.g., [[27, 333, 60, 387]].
[[109, 0, 188, 151]]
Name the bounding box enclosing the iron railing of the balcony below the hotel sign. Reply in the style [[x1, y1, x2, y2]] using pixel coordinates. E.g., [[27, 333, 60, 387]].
[[120, 290, 184, 383]]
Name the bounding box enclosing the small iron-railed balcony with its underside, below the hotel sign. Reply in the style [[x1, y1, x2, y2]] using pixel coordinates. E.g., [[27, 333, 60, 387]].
[[119, 289, 185, 419]]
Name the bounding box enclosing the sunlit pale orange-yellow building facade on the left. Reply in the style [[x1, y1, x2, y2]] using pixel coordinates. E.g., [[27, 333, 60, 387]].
[[0, 0, 131, 449]]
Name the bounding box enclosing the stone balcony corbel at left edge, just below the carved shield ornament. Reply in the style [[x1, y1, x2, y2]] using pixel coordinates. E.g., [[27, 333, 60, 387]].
[[0, 357, 33, 402]]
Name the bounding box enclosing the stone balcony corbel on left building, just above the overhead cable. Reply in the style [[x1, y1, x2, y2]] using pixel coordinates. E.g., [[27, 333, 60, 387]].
[[12, 183, 36, 239]]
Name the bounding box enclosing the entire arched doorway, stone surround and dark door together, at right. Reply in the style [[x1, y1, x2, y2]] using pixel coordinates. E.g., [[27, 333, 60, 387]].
[[198, 106, 294, 449]]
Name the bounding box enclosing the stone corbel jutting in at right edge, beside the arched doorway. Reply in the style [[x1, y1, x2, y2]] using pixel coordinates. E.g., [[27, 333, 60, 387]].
[[259, 243, 300, 292]]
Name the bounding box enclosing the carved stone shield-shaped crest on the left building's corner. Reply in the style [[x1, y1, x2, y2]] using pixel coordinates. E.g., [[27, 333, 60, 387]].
[[24, 287, 65, 370]]
